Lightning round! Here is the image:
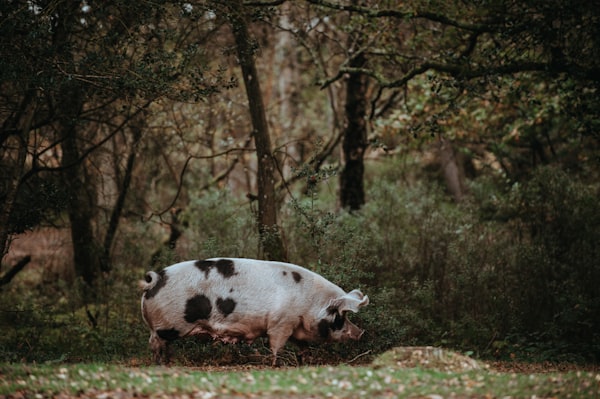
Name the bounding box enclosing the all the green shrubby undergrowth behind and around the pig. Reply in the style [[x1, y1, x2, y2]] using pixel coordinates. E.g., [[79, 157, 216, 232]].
[[0, 161, 600, 365]]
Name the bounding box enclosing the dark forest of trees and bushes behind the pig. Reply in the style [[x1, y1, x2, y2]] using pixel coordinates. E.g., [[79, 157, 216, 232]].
[[0, 0, 600, 362]]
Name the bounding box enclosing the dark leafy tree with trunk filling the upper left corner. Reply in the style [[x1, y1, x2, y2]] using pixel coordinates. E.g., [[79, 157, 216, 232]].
[[0, 1, 221, 287]]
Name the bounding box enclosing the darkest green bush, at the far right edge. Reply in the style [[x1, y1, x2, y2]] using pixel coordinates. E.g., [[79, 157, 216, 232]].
[[492, 167, 600, 358]]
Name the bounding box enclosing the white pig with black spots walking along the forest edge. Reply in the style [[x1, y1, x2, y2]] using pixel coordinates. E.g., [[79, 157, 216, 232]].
[[140, 258, 369, 366]]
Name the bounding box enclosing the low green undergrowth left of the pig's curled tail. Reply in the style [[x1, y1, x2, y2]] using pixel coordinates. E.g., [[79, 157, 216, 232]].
[[0, 269, 148, 362]]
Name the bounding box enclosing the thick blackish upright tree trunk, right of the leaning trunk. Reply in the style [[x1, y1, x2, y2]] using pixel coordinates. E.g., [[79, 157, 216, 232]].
[[340, 39, 368, 210]]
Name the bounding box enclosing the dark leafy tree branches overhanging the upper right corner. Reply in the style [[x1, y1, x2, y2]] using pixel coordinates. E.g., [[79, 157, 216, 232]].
[[308, 0, 600, 198]]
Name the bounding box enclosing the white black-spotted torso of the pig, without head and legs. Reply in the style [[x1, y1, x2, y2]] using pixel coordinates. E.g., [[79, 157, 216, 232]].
[[146, 258, 344, 324]]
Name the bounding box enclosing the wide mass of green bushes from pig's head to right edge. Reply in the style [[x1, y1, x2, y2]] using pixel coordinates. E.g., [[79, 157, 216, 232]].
[[284, 161, 600, 360]]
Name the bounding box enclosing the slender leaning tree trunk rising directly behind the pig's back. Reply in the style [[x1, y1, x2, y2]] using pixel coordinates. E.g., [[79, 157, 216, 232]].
[[229, 0, 287, 260]]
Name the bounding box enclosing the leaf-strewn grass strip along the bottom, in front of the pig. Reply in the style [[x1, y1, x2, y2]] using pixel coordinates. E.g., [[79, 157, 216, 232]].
[[0, 348, 600, 398]]
